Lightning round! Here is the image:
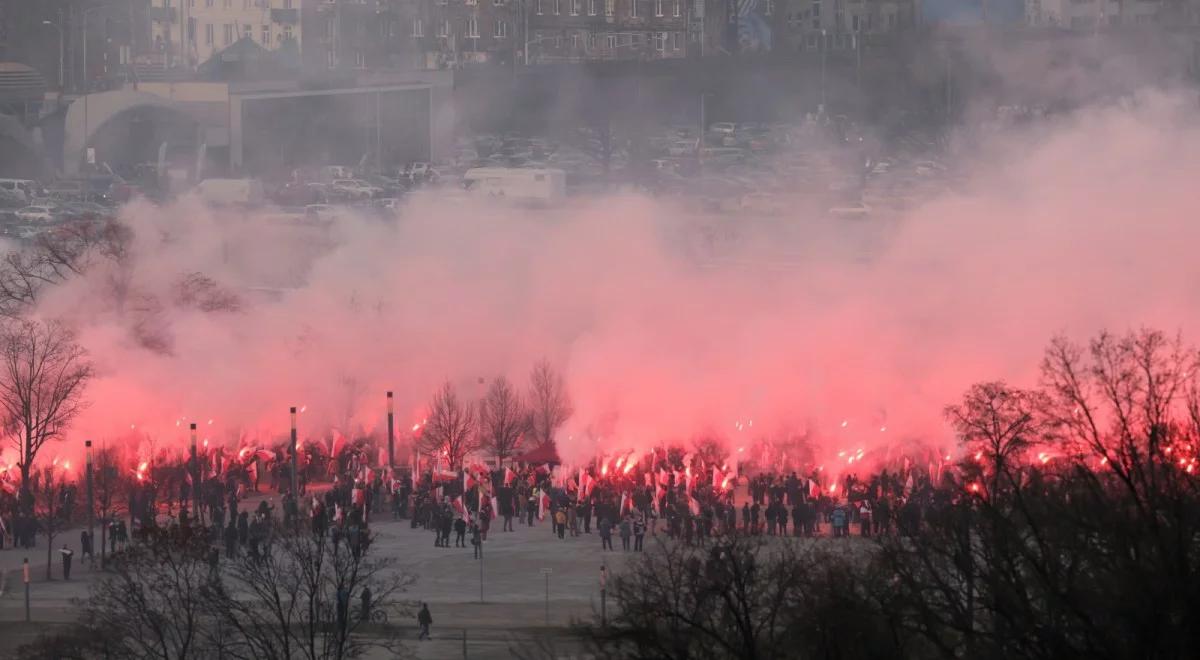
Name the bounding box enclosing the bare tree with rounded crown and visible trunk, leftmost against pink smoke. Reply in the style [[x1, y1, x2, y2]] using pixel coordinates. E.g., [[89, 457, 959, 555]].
[[0, 319, 92, 501]]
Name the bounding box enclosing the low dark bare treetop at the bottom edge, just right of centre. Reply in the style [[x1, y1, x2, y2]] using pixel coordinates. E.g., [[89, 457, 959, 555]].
[[528, 535, 912, 660]]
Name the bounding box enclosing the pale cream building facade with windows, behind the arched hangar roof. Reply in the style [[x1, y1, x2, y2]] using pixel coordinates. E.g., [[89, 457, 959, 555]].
[[150, 0, 302, 67]]
